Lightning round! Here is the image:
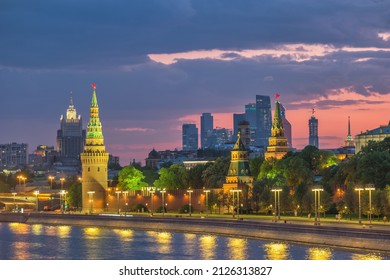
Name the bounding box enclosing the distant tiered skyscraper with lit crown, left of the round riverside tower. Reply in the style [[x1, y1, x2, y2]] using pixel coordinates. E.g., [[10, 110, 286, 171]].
[[57, 98, 85, 165]]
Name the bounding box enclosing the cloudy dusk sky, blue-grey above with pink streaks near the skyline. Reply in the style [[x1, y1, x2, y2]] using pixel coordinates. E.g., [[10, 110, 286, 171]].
[[0, 0, 390, 165]]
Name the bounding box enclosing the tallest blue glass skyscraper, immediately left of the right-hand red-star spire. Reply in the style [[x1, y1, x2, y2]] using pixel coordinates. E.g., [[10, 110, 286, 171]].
[[256, 95, 272, 147]]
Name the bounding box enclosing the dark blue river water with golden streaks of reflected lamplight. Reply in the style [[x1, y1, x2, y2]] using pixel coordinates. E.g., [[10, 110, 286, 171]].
[[0, 223, 390, 260]]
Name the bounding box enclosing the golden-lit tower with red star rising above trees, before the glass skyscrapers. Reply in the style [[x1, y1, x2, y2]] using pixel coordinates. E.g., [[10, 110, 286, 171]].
[[264, 98, 288, 159]]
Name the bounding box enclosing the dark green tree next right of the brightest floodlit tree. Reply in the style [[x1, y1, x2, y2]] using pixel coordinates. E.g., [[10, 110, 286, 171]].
[[154, 164, 188, 190]]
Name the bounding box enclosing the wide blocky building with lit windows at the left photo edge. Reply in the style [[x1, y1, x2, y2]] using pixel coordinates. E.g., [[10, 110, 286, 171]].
[[0, 143, 28, 167]]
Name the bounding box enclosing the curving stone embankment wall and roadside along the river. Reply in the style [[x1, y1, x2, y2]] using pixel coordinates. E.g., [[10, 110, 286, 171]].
[[0, 213, 390, 252]]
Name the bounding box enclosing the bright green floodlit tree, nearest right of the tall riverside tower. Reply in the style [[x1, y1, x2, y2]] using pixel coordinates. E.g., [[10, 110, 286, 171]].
[[118, 165, 147, 190]]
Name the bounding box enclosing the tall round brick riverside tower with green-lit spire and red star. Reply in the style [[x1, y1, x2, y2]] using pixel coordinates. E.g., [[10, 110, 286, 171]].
[[80, 84, 108, 213]]
